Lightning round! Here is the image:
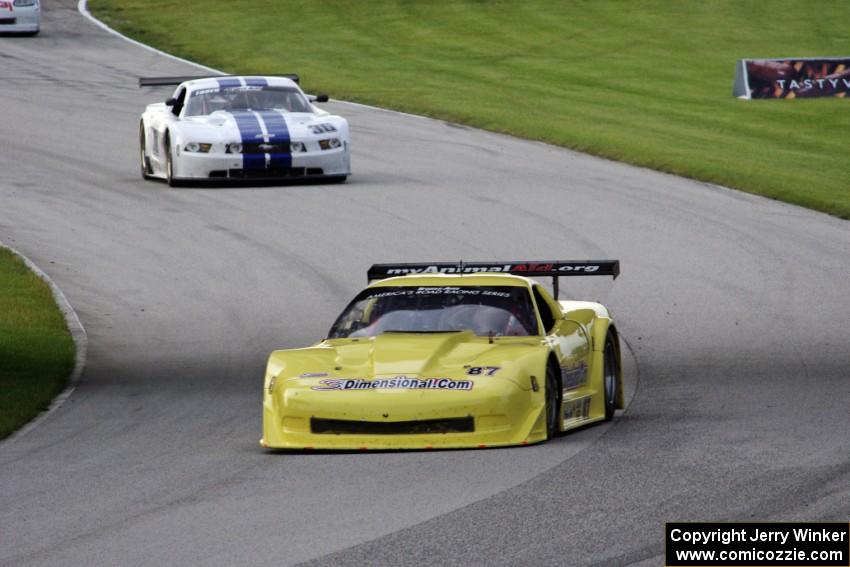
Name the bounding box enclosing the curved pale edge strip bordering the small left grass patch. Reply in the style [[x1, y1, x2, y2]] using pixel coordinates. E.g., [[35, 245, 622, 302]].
[[0, 242, 89, 447]]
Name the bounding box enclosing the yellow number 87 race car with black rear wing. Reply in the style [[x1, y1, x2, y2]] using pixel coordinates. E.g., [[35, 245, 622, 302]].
[[260, 260, 623, 450]]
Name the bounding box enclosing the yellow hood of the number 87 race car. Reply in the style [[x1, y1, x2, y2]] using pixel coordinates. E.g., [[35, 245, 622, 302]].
[[269, 331, 545, 386]]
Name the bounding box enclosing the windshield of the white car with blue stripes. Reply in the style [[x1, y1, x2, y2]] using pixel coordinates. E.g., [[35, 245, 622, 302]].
[[184, 87, 313, 116]]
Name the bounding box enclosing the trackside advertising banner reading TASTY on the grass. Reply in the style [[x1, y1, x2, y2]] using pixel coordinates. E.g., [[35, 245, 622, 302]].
[[733, 57, 850, 99]]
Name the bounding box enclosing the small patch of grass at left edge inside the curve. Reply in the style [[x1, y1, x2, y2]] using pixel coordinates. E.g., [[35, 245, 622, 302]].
[[0, 248, 74, 439]]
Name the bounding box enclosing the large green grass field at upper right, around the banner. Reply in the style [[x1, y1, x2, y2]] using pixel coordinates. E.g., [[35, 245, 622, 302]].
[[90, 0, 850, 218]]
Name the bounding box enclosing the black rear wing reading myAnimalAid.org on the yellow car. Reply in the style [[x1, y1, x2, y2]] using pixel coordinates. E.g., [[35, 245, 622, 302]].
[[366, 260, 620, 298]]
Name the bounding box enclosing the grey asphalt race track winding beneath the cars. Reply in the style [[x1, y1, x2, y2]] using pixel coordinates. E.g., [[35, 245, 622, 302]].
[[0, 0, 850, 566]]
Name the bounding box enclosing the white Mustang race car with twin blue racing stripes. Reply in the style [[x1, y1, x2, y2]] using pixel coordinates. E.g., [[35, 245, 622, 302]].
[[139, 75, 351, 186]]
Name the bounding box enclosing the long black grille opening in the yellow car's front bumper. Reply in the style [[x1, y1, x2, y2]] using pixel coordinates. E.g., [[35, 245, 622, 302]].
[[310, 416, 475, 435]]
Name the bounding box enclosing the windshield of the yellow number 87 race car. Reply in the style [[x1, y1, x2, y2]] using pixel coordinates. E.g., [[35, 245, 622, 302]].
[[328, 286, 538, 338]]
